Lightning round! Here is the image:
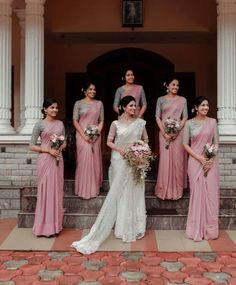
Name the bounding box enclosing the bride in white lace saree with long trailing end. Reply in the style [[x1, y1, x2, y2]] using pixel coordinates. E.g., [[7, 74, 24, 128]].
[[71, 96, 148, 254]]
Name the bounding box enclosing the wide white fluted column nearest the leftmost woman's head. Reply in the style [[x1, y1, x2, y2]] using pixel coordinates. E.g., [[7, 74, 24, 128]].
[[20, 0, 46, 134]]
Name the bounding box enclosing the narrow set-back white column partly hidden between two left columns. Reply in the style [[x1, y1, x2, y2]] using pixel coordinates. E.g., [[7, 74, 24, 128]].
[[14, 9, 25, 132]]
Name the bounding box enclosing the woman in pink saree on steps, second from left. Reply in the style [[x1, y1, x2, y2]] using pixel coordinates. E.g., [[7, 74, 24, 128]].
[[73, 83, 104, 199]]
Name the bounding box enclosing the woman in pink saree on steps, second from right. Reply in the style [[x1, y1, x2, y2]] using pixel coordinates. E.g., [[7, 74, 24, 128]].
[[155, 77, 188, 200]]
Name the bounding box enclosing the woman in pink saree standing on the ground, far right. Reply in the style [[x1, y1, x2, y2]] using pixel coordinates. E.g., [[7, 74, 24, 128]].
[[183, 97, 219, 241]]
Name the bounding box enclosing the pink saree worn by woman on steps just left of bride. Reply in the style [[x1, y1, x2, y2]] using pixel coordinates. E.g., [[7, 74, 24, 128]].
[[75, 101, 103, 199]]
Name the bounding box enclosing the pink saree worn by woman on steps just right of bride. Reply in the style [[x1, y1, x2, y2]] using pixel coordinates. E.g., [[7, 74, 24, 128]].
[[155, 97, 187, 200]]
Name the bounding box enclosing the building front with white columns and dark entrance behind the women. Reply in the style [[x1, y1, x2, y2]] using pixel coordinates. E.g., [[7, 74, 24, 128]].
[[0, 0, 236, 217]]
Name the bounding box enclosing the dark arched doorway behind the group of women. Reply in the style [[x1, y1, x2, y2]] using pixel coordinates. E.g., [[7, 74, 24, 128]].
[[65, 48, 195, 179]]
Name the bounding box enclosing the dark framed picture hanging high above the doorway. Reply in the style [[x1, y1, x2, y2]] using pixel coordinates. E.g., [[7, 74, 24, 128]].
[[122, 0, 143, 27]]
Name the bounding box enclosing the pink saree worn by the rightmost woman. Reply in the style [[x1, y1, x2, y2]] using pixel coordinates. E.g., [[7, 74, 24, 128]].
[[186, 118, 219, 241]]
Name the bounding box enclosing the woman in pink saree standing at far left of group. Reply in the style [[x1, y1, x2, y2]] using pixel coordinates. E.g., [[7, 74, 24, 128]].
[[29, 99, 66, 237]]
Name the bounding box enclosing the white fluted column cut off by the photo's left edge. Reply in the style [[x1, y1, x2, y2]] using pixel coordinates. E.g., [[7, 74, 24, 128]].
[[0, 0, 15, 134]]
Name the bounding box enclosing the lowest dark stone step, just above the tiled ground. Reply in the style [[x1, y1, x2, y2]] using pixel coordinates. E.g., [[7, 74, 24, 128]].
[[18, 209, 236, 230]]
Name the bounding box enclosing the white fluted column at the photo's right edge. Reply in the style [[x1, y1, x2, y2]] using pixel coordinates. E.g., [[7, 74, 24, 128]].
[[217, 0, 236, 142]]
